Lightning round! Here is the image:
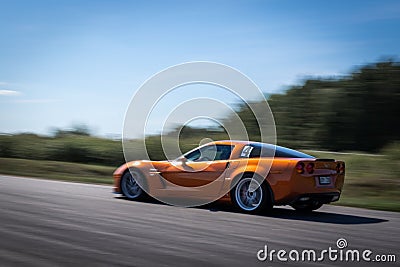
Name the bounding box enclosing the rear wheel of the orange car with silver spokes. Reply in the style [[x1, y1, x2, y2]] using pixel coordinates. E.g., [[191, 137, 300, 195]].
[[231, 177, 270, 213]]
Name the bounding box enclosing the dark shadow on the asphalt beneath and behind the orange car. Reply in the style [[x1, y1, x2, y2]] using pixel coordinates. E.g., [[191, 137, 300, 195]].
[[115, 198, 388, 224]]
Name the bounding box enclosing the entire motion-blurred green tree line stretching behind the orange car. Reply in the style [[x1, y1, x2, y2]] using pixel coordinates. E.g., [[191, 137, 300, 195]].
[[0, 61, 400, 165]]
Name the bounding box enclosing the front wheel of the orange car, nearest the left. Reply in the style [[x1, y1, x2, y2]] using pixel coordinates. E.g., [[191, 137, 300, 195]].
[[121, 171, 146, 200]]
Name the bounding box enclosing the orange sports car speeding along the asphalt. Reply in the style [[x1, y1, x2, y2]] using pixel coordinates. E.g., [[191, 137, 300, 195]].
[[114, 140, 345, 212]]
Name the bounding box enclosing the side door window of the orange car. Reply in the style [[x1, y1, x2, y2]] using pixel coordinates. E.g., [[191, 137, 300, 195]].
[[183, 145, 233, 162]]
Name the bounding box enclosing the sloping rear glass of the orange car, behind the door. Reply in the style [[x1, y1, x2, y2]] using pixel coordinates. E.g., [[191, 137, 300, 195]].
[[240, 143, 314, 158]]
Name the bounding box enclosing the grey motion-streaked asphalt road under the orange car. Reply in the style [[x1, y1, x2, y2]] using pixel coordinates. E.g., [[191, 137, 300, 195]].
[[0, 176, 400, 267]]
